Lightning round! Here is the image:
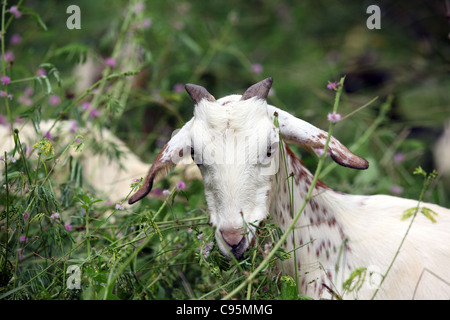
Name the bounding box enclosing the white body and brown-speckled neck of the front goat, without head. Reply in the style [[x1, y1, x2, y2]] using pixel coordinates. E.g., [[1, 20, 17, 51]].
[[270, 147, 450, 299]]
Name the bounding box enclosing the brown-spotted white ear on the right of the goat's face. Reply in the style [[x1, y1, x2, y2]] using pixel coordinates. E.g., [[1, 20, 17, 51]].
[[268, 106, 369, 169]]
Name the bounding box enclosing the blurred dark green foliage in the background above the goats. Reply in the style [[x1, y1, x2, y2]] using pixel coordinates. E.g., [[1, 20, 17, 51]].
[[6, 0, 450, 206]]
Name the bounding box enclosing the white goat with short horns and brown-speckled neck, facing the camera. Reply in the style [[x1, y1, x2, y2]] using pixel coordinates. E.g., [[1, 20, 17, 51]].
[[129, 78, 450, 299]]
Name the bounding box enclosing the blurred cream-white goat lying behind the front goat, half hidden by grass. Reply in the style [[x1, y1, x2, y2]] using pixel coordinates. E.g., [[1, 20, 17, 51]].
[[0, 119, 198, 203]]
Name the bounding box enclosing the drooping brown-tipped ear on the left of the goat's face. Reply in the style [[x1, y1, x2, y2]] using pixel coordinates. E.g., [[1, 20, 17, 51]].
[[128, 120, 192, 204]]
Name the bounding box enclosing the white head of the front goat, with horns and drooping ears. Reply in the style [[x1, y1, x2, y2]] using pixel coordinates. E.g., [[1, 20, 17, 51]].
[[129, 78, 368, 258]]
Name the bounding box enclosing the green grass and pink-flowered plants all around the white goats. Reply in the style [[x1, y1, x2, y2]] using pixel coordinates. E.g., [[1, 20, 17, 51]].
[[0, 0, 450, 299]]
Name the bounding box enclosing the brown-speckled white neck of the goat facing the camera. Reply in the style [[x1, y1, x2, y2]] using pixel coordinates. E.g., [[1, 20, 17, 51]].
[[270, 145, 355, 296]]
